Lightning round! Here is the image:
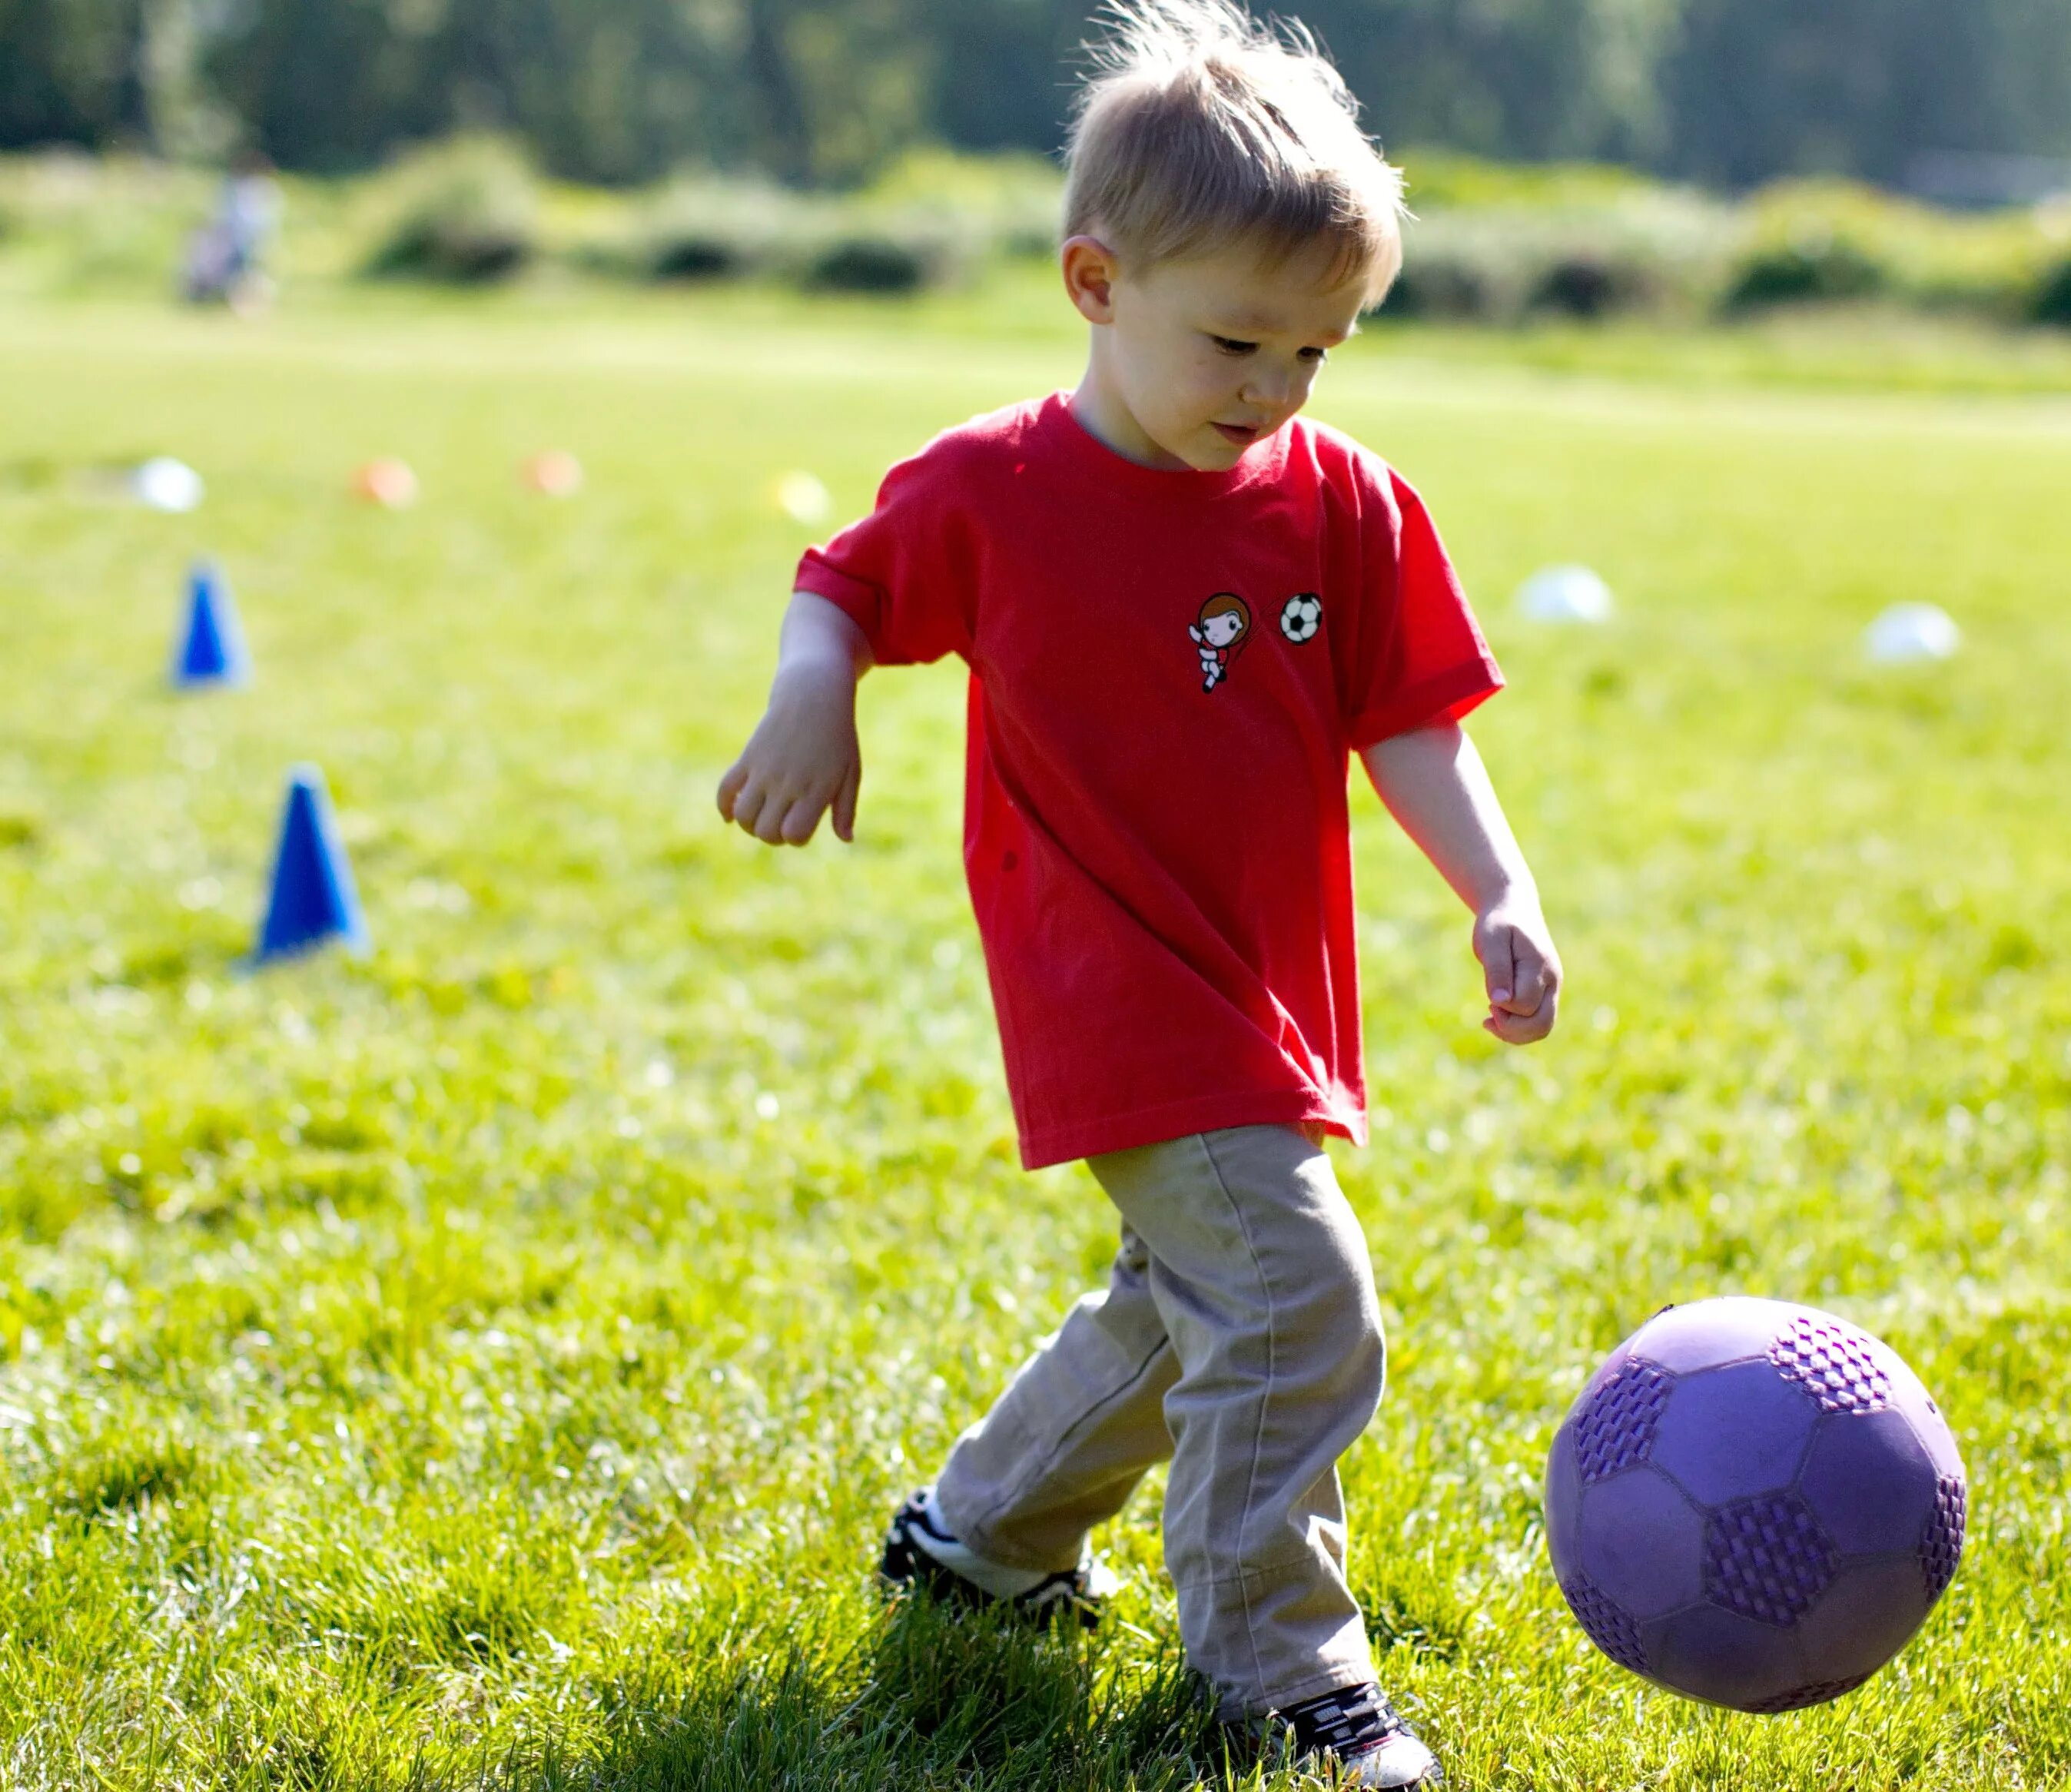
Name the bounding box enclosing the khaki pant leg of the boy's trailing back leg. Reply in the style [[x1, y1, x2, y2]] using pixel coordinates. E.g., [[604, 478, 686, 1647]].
[[936, 1226, 1178, 1572]]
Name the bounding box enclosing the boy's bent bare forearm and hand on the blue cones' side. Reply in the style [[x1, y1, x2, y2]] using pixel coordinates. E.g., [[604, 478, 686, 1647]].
[[719, 590, 870, 845]]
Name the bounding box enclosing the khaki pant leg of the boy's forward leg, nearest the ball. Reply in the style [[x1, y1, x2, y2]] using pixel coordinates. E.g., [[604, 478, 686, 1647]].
[[1091, 1127, 1383, 1717]]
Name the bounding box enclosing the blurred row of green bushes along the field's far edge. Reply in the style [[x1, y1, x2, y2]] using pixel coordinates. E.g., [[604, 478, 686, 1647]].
[[0, 137, 2071, 327]]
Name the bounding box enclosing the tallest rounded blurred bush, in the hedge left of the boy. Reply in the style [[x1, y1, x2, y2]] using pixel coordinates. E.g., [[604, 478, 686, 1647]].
[[363, 137, 539, 286]]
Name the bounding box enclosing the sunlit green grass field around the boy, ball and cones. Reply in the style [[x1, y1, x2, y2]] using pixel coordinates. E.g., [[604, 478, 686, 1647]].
[[0, 286, 2071, 1792]]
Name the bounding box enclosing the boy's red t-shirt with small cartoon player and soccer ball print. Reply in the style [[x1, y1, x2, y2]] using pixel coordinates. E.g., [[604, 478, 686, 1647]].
[[798, 393, 1502, 1169]]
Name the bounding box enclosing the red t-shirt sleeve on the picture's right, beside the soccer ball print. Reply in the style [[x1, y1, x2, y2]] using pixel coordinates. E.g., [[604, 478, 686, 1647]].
[[1344, 462, 1504, 752]]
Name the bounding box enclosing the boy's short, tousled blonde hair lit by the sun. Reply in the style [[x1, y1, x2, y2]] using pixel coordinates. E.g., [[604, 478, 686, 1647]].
[[1064, 0, 1406, 304]]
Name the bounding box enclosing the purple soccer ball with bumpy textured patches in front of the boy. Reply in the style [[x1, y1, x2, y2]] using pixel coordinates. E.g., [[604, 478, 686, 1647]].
[[1545, 1295, 1966, 1711]]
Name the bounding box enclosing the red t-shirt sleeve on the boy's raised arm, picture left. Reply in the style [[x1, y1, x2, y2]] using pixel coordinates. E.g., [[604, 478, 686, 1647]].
[[793, 441, 977, 665]]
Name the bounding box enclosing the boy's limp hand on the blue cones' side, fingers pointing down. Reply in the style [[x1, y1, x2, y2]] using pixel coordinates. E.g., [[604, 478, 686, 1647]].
[[719, 663, 864, 845]]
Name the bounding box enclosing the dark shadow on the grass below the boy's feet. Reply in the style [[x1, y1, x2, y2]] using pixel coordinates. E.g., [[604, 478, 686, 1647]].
[[526, 1599, 1251, 1792]]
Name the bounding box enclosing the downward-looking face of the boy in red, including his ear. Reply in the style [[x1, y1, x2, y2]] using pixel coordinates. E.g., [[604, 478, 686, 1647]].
[[1064, 236, 1367, 473]]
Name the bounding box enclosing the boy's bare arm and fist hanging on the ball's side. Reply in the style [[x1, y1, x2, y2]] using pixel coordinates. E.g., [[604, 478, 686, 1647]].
[[1361, 721, 1562, 1046]]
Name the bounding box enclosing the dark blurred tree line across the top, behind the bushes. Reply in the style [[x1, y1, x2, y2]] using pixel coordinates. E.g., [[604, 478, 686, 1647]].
[[0, 0, 2071, 187]]
